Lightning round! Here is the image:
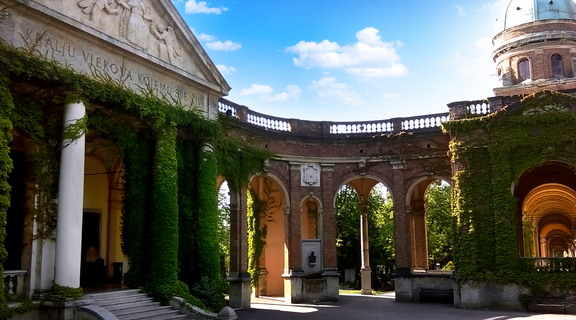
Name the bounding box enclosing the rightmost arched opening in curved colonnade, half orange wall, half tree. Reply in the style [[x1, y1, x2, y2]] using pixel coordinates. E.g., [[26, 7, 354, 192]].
[[407, 177, 456, 271]]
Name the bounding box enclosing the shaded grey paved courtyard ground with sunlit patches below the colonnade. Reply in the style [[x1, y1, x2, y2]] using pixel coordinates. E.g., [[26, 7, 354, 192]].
[[237, 293, 576, 320]]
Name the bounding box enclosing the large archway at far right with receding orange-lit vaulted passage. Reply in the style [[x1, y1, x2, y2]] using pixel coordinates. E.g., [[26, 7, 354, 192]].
[[515, 163, 576, 258]]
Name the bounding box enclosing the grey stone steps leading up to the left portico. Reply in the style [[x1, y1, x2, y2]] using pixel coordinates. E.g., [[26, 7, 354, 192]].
[[83, 289, 187, 320]]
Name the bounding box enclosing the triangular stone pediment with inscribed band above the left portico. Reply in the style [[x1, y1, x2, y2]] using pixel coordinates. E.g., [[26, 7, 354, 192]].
[[0, 0, 230, 117]]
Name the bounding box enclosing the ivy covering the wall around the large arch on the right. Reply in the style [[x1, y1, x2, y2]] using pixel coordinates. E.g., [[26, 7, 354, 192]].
[[443, 91, 576, 293]]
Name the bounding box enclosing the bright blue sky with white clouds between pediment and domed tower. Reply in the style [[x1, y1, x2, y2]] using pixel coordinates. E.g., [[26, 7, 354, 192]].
[[173, 0, 508, 121]]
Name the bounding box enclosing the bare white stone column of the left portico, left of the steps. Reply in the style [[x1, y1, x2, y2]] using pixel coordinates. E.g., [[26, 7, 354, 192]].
[[54, 102, 86, 288]]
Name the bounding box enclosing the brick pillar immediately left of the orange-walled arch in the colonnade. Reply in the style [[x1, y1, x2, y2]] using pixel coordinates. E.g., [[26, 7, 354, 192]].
[[228, 187, 252, 309]]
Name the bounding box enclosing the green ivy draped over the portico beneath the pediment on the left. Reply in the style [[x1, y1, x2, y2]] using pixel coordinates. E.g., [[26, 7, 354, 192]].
[[0, 40, 270, 306]]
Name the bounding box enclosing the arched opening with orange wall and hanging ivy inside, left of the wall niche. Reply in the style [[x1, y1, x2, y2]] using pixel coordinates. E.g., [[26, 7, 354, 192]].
[[248, 176, 287, 297]]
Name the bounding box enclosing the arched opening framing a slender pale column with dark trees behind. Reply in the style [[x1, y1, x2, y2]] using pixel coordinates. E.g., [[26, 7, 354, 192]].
[[335, 178, 395, 294]]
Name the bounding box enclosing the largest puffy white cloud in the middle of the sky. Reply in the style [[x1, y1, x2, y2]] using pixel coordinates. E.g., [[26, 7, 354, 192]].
[[286, 27, 408, 77]]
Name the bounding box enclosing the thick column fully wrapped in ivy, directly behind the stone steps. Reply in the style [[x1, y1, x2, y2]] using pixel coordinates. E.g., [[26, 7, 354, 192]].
[[148, 126, 178, 301]]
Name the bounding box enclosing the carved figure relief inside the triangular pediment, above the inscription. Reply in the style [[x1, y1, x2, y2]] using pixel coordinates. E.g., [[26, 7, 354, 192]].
[[77, 0, 182, 67]]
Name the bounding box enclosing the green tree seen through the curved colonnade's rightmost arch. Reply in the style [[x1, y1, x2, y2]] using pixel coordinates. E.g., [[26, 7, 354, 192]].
[[425, 181, 456, 266]]
